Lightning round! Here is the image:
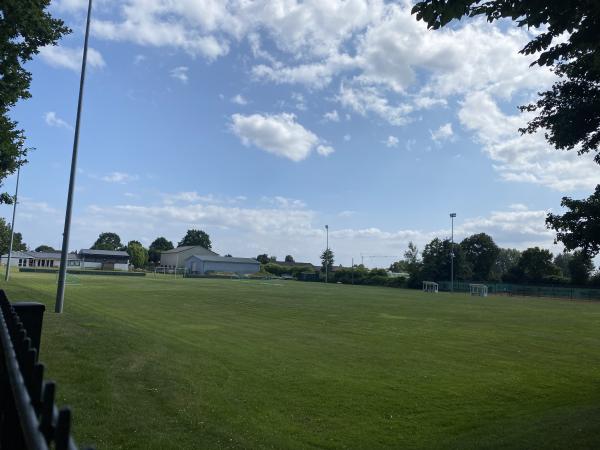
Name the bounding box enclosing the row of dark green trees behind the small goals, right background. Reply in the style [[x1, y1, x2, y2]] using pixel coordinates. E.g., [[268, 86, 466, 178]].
[[389, 233, 600, 287]]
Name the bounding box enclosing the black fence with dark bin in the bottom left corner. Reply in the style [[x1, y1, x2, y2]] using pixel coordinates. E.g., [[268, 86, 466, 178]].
[[0, 290, 91, 450]]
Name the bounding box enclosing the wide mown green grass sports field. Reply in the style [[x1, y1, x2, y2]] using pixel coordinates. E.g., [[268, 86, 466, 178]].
[[0, 274, 600, 449]]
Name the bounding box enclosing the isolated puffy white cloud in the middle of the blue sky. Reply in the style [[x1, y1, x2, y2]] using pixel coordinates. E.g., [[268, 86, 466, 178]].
[[231, 113, 333, 162]]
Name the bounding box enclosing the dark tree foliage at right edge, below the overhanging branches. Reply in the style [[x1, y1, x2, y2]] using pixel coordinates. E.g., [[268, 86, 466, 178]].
[[546, 185, 600, 258]]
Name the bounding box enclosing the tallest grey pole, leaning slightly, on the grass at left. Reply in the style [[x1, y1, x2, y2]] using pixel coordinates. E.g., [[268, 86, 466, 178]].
[[54, 0, 92, 313]]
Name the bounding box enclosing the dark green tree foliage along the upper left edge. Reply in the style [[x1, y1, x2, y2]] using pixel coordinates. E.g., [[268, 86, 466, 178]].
[[0, 0, 70, 203]]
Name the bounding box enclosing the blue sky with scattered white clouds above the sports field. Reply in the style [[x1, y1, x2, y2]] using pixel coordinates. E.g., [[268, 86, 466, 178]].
[[3, 0, 600, 266]]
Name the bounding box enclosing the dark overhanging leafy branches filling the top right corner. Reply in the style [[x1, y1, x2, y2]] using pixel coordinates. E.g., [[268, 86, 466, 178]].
[[412, 0, 600, 164]]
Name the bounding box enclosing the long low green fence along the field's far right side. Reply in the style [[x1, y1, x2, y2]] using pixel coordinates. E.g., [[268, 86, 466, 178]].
[[439, 281, 600, 300]]
